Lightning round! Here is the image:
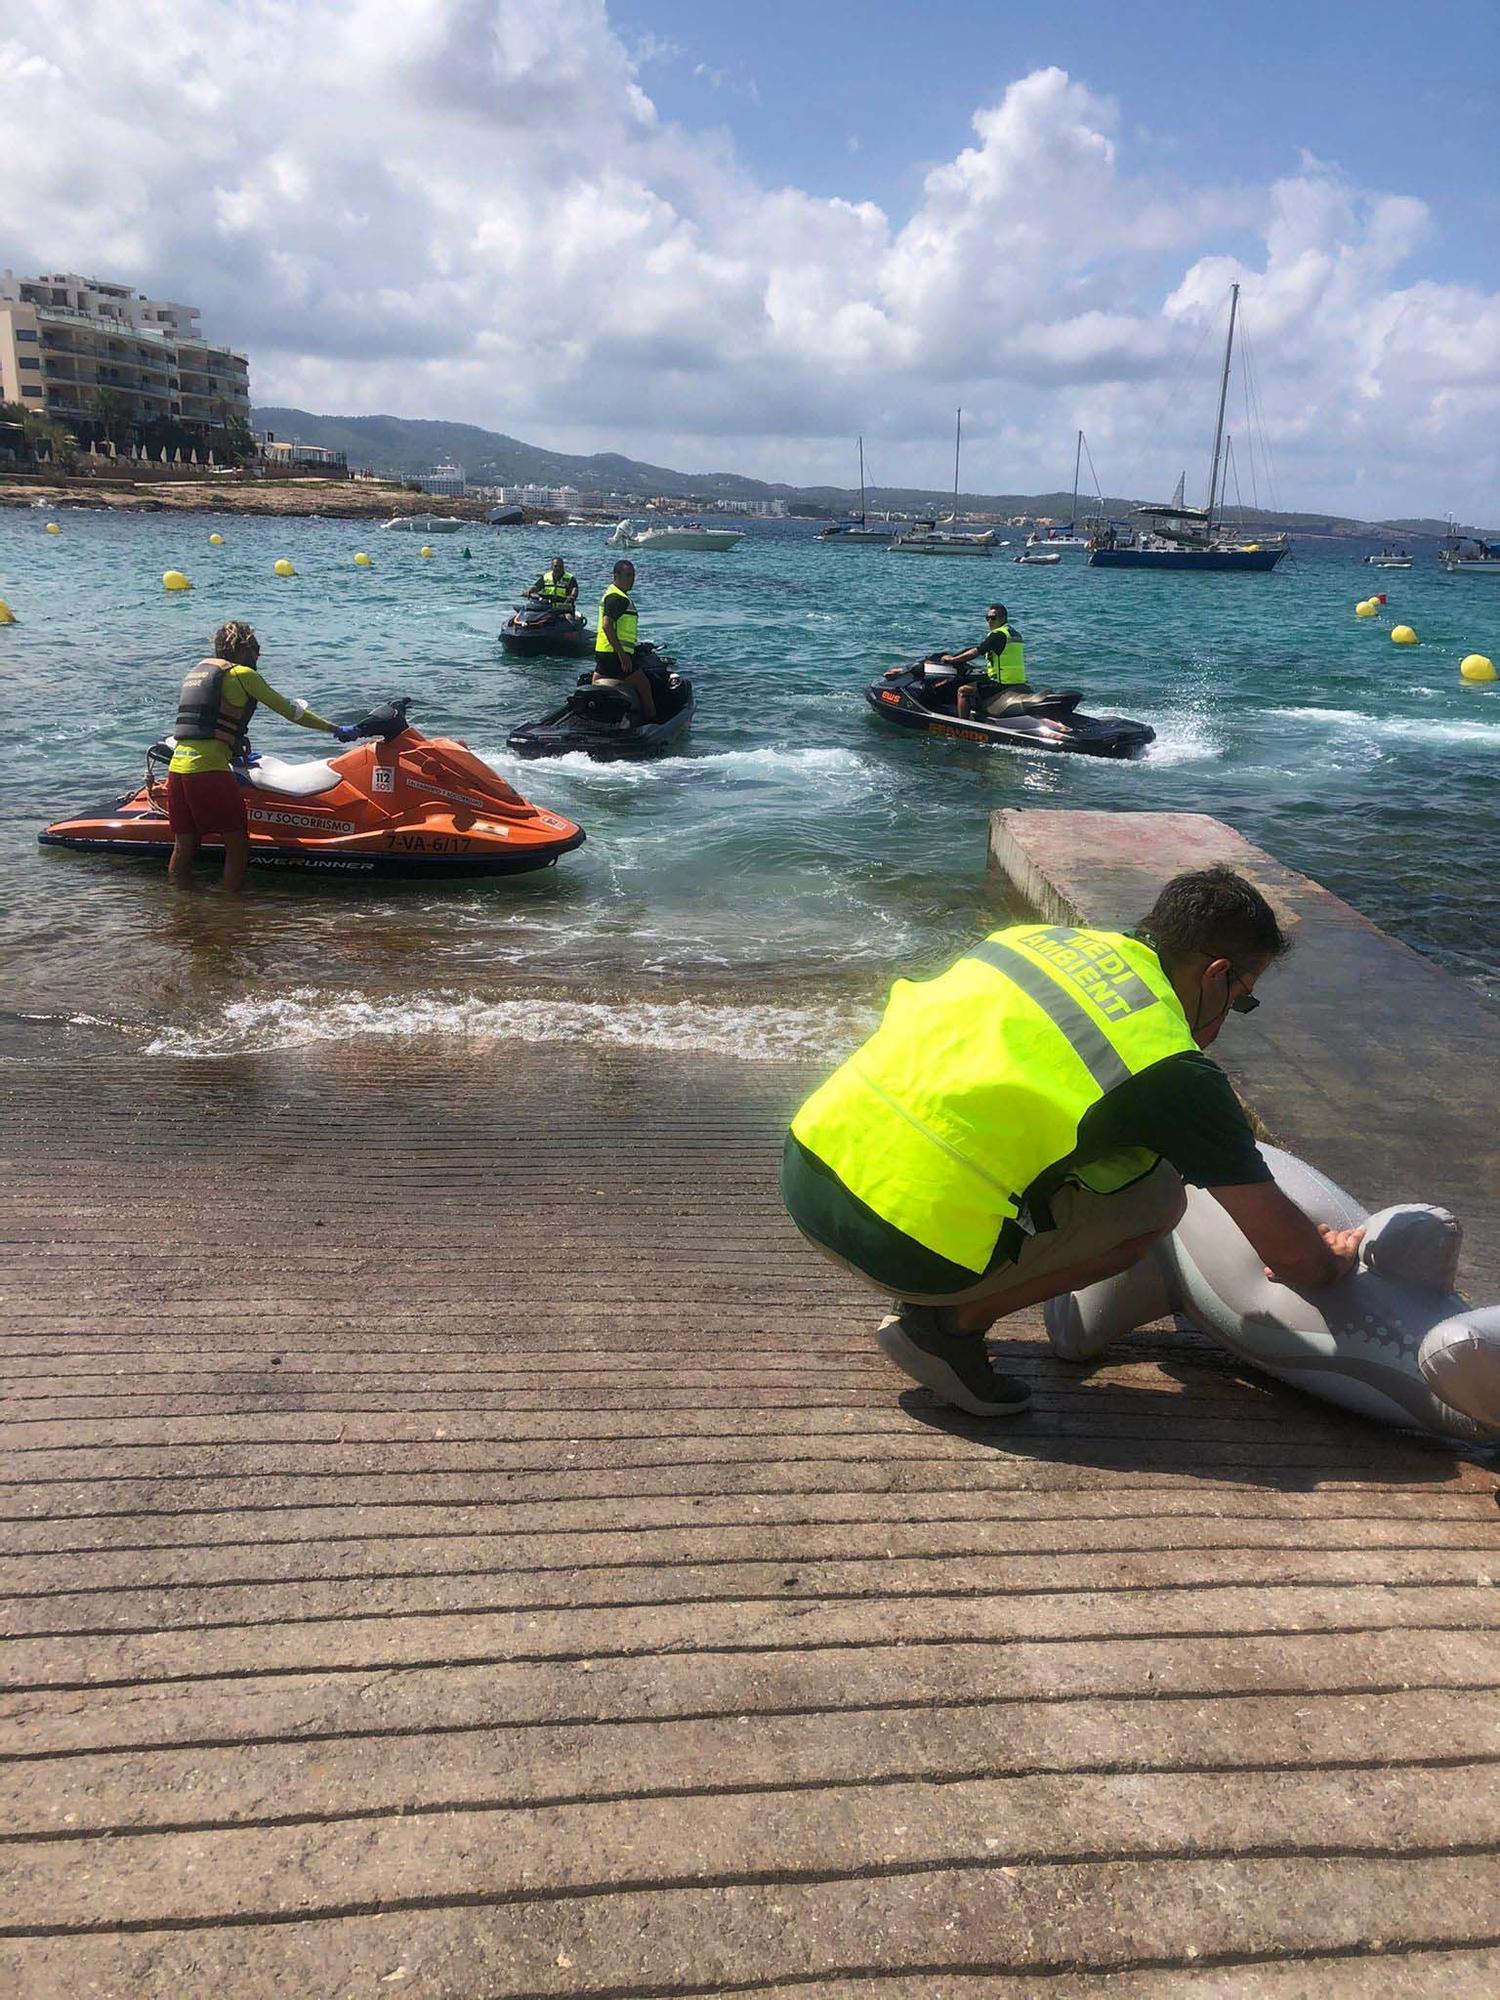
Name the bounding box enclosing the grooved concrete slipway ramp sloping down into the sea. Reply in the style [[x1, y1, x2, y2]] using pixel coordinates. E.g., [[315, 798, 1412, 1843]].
[[0, 1044, 1500, 2000]]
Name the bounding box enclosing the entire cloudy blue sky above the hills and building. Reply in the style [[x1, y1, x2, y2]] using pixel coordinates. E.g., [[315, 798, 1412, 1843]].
[[0, 0, 1500, 518]]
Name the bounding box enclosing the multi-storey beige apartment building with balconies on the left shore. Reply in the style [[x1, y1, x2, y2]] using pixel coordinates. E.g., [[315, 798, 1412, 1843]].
[[0, 270, 250, 432]]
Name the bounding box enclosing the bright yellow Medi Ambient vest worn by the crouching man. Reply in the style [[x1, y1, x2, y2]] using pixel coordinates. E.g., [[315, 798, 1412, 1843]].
[[792, 924, 1198, 1274]]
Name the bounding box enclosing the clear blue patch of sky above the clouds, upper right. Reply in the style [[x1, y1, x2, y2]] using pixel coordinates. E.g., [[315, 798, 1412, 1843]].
[[624, 0, 1500, 286]]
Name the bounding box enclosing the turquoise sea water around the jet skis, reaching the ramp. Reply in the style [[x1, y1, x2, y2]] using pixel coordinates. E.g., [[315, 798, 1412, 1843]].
[[0, 510, 1500, 1054]]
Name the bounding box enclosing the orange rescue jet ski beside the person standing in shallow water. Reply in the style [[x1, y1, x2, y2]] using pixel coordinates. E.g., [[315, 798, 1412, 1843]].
[[38, 698, 584, 876]]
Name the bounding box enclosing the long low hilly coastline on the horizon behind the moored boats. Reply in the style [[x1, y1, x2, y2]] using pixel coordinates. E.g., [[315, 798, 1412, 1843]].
[[250, 404, 1490, 540]]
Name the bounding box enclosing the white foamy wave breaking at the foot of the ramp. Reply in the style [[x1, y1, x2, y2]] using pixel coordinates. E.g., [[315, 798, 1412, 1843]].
[[146, 988, 874, 1062]]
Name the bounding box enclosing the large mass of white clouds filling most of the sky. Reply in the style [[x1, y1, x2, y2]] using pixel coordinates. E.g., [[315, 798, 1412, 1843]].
[[0, 0, 1500, 512]]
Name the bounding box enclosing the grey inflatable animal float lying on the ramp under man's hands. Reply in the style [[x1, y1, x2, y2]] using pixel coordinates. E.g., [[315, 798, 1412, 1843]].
[[1046, 1146, 1500, 1444]]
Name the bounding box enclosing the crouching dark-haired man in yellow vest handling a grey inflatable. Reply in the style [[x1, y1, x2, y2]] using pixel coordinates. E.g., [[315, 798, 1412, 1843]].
[[782, 868, 1362, 1416]]
